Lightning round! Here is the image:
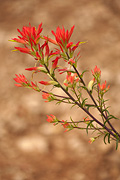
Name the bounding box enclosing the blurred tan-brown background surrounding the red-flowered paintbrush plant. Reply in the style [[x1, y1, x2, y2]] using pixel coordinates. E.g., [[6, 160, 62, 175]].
[[0, 0, 120, 180]]
